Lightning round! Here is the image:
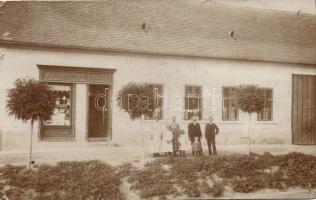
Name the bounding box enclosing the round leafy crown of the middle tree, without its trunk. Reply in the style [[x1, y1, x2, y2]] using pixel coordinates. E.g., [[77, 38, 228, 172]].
[[116, 82, 155, 120]]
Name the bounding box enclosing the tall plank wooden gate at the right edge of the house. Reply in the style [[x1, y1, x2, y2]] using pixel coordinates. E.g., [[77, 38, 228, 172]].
[[292, 75, 316, 145]]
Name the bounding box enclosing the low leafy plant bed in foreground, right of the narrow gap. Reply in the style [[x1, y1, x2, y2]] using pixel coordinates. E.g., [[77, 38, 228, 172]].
[[129, 152, 316, 198]]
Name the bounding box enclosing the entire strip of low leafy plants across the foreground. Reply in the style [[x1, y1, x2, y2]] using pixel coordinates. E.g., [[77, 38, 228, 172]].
[[0, 152, 316, 200]]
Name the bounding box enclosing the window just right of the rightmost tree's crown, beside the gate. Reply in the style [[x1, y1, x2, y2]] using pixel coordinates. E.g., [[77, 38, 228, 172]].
[[257, 88, 273, 121]]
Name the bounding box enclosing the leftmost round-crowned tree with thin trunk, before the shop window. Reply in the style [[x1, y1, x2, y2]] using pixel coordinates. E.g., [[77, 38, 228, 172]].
[[6, 79, 55, 168]]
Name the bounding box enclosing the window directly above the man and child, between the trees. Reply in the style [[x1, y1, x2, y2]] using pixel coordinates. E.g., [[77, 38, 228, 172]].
[[184, 86, 202, 120]]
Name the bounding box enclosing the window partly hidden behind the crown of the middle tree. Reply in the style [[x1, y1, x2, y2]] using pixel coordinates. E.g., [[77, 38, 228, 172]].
[[145, 84, 164, 120]]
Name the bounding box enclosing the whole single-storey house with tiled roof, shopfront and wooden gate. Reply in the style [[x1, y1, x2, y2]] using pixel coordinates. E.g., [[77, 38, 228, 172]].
[[0, 0, 316, 151]]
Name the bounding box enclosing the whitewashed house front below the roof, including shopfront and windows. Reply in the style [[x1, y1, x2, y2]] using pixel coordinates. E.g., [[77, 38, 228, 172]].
[[1, 46, 316, 150]]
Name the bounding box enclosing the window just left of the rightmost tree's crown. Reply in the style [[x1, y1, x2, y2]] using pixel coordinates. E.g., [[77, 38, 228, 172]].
[[222, 87, 239, 121]]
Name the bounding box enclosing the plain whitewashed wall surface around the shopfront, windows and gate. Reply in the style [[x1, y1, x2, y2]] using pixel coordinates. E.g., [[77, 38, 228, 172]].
[[0, 47, 316, 151]]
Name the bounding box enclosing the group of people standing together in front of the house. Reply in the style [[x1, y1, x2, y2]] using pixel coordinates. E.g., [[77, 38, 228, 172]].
[[151, 111, 219, 157]]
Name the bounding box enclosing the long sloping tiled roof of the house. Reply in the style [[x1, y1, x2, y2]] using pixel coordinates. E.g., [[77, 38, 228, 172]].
[[0, 0, 316, 64]]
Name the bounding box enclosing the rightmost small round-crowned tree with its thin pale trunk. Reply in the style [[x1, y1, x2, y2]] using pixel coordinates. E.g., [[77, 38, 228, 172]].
[[237, 85, 265, 154]]
